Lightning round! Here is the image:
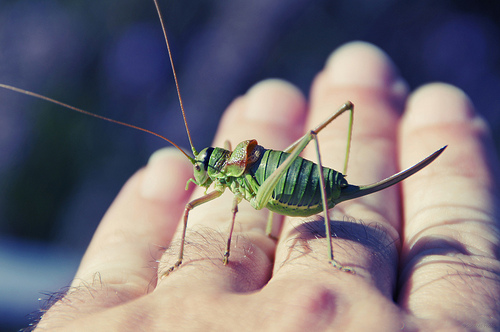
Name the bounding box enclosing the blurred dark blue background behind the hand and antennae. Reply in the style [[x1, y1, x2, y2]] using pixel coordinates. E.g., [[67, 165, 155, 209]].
[[0, 0, 500, 331]]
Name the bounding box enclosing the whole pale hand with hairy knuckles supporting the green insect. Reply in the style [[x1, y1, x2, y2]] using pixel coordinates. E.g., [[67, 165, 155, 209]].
[[33, 42, 500, 331]]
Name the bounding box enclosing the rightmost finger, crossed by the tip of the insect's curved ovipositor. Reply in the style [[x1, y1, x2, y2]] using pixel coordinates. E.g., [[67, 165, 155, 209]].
[[399, 84, 500, 329]]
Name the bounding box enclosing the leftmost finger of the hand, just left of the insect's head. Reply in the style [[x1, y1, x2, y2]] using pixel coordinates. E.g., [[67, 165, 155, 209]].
[[72, 148, 192, 300]]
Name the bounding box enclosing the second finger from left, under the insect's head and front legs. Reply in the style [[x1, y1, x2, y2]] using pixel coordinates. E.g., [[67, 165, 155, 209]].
[[160, 80, 305, 290]]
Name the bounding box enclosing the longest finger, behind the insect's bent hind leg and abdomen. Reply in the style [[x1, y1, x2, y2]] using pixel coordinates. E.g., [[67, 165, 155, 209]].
[[277, 43, 406, 294]]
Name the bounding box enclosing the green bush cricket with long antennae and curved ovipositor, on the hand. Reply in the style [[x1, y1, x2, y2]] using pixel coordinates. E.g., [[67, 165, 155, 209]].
[[0, 0, 446, 275]]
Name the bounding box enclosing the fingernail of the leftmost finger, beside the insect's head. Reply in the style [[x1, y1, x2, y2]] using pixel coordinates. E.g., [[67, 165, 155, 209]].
[[141, 147, 192, 202]]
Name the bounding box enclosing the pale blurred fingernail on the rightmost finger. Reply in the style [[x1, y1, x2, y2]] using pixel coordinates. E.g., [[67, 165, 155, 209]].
[[405, 83, 476, 127]]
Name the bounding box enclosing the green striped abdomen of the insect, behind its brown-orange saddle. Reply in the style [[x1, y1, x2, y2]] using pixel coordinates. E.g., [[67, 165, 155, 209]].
[[249, 150, 345, 216]]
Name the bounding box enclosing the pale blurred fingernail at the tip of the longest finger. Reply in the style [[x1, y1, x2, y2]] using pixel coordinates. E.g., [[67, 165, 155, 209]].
[[325, 41, 408, 96]]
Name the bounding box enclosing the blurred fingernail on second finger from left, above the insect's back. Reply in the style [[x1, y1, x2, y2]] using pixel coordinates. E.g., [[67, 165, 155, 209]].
[[245, 79, 306, 126]]
